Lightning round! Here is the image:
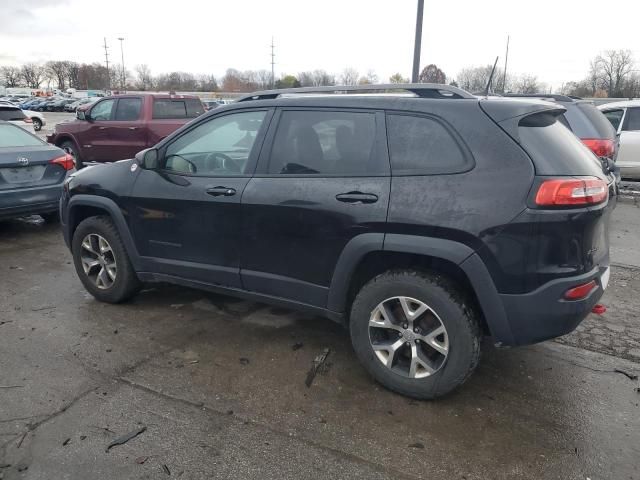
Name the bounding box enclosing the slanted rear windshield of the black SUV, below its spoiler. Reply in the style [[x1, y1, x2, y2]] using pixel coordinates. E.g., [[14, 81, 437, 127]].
[[518, 113, 608, 176]]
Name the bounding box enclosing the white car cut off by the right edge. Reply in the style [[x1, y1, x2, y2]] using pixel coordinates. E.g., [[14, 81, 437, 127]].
[[598, 100, 640, 180]]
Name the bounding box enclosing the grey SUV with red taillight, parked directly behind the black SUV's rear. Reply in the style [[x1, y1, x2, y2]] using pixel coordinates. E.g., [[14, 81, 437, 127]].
[[505, 93, 618, 171]]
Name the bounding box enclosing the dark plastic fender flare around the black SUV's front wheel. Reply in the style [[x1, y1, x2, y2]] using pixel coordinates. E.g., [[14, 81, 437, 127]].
[[65, 194, 142, 271]]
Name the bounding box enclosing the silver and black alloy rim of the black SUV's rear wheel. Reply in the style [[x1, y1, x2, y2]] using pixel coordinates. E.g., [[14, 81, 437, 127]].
[[369, 297, 449, 378]]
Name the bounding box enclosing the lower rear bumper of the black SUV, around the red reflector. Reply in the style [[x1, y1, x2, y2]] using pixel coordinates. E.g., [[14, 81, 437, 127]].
[[500, 266, 608, 346]]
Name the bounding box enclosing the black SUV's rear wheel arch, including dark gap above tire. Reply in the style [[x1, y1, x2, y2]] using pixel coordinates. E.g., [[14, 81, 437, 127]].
[[327, 233, 513, 344]]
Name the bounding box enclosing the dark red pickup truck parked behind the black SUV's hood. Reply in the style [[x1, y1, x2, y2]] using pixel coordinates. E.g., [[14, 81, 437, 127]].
[[47, 94, 205, 169]]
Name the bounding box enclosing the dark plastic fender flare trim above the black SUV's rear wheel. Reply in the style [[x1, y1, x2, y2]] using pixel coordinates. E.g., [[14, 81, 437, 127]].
[[327, 233, 513, 345]]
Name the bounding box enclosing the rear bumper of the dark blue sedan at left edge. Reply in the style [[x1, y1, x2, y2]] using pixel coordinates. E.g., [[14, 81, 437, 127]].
[[0, 183, 62, 219]]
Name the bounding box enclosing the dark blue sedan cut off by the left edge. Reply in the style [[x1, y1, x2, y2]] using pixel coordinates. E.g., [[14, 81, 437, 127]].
[[0, 120, 73, 222]]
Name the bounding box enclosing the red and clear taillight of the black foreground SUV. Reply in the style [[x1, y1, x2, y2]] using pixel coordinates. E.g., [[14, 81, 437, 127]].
[[536, 178, 609, 206]]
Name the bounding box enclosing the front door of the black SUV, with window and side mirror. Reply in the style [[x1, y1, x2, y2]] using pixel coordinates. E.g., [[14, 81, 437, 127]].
[[130, 110, 269, 287]]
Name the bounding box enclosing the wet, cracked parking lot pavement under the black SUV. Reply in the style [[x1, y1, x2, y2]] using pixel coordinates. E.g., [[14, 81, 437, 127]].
[[0, 211, 640, 480]]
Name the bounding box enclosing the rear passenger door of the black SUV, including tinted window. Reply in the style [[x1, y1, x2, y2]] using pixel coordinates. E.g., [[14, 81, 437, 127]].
[[240, 109, 390, 307]]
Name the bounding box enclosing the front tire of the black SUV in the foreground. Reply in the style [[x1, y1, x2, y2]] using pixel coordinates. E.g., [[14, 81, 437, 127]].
[[71, 216, 140, 303]]
